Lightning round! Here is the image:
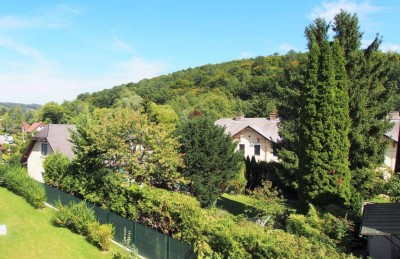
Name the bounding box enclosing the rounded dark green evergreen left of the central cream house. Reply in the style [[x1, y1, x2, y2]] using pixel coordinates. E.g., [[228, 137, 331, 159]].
[[178, 117, 243, 207]]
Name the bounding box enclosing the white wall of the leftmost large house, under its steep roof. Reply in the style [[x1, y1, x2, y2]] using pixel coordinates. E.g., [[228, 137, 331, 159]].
[[27, 141, 53, 183]]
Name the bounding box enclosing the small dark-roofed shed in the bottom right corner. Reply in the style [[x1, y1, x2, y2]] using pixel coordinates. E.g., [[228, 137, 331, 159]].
[[361, 203, 400, 259]]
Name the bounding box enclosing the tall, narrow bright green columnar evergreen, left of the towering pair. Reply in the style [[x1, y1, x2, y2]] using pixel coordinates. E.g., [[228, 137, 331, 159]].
[[298, 19, 350, 204]]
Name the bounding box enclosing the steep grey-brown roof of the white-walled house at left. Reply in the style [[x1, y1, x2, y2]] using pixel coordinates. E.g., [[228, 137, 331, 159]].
[[21, 124, 76, 162]]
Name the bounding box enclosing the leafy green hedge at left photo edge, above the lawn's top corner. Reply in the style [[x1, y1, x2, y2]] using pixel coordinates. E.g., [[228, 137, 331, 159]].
[[0, 165, 46, 208]]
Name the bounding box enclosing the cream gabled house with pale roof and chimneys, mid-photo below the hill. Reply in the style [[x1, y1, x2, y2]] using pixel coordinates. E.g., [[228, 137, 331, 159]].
[[215, 114, 280, 162]]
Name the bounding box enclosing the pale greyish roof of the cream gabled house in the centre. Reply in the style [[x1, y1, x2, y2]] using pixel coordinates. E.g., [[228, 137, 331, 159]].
[[215, 118, 281, 142]]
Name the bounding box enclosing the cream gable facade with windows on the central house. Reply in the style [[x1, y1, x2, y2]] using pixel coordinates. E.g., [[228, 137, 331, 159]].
[[233, 127, 278, 162]]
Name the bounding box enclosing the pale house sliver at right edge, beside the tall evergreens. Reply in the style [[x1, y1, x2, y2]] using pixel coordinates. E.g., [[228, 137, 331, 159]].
[[383, 112, 400, 171]]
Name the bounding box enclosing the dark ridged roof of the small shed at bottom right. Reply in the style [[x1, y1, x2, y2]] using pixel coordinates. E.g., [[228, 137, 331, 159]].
[[361, 203, 400, 236]]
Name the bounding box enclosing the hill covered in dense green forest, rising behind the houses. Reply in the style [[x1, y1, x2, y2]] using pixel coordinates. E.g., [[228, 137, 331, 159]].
[[69, 51, 400, 122]]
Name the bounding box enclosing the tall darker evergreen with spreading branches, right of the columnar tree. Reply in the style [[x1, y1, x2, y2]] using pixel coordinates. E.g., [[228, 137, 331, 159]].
[[333, 11, 396, 170]]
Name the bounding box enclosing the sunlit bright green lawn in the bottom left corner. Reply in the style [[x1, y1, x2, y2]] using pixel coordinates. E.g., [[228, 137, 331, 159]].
[[0, 187, 121, 259]]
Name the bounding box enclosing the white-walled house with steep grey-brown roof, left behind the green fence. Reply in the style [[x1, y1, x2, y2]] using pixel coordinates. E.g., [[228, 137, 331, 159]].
[[21, 124, 76, 182]]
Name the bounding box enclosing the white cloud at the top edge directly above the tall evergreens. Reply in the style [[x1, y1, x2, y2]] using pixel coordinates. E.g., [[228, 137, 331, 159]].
[[308, 0, 382, 21]]
